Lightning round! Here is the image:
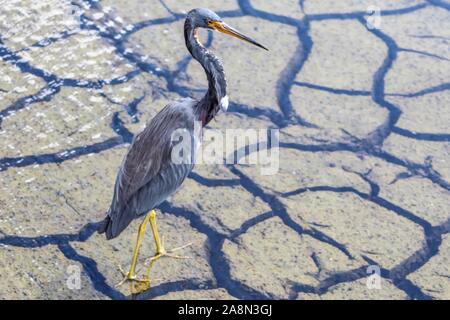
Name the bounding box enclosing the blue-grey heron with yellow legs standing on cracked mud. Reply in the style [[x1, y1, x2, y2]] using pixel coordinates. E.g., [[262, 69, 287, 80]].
[[98, 8, 268, 288]]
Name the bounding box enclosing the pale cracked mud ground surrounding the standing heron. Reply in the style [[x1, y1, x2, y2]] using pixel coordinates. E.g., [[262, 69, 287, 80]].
[[0, 0, 450, 299]]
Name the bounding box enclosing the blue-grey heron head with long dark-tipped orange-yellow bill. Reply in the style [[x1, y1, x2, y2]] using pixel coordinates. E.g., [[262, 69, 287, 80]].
[[188, 8, 269, 50]]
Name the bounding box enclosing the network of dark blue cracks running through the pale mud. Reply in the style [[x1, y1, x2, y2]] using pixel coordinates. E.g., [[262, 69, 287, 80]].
[[0, 0, 450, 299]]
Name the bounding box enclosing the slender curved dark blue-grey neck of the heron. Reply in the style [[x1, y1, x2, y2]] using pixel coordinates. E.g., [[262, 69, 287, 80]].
[[184, 18, 228, 125]]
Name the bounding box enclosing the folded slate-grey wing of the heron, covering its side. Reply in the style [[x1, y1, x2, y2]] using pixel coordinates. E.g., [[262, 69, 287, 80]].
[[105, 99, 199, 236]]
